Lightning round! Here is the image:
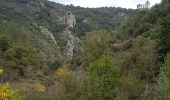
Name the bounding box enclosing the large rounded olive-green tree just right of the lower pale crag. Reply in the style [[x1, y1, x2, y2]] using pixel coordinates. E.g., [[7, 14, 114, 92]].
[[82, 30, 112, 63]]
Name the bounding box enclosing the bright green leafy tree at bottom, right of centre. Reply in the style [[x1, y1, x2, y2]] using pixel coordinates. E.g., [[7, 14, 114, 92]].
[[80, 55, 121, 100]]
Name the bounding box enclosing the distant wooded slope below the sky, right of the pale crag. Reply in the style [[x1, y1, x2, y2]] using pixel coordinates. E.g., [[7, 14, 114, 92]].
[[56, 4, 136, 37]]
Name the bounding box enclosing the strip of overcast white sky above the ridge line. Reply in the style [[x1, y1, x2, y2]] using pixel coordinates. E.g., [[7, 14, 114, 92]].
[[49, 0, 161, 8]]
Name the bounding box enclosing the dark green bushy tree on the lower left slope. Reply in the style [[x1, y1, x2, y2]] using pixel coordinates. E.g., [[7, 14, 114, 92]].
[[5, 45, 42, 76]]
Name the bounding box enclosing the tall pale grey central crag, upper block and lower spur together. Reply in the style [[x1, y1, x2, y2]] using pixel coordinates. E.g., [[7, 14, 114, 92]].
[[51, 9, 78, 60]]
